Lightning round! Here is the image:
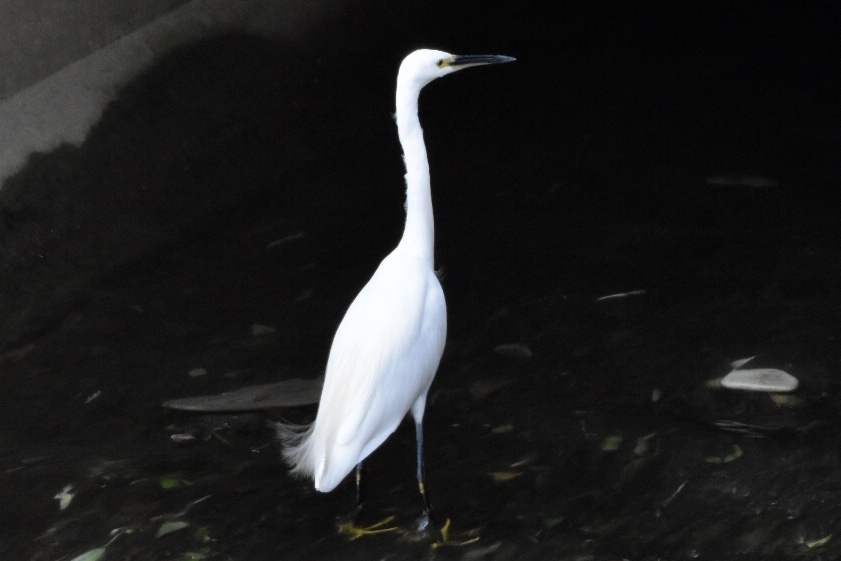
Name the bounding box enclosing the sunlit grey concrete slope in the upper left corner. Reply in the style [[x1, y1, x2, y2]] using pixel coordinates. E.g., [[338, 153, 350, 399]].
[[0, 0, 348, 184]]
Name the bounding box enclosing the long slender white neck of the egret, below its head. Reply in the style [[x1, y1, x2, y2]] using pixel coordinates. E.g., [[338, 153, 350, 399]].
[[396, 77, 435, 268]]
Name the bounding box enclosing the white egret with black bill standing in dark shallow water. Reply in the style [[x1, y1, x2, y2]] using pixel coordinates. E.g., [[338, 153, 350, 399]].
[[278, 49, 514, 528]]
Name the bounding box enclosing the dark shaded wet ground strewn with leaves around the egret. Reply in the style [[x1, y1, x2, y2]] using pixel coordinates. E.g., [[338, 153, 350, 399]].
[[0, 5, 841, 561]]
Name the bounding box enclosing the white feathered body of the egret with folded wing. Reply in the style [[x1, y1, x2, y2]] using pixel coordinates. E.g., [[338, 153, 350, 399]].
[[310, 251, 446, 491]]
